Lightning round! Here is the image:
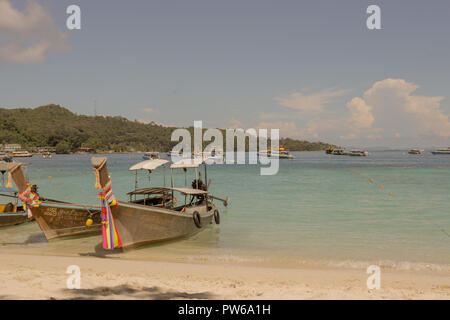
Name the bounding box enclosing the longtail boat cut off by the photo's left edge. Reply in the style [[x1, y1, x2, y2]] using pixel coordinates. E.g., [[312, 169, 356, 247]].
[[0, 161, 29, 227]]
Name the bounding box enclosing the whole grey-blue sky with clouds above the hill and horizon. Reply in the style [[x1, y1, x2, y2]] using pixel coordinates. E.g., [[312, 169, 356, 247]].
[[0, 0, 450, 147]]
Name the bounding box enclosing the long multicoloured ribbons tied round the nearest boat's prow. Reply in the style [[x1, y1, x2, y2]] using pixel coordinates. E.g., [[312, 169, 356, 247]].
[[95, 174, 122, 250]]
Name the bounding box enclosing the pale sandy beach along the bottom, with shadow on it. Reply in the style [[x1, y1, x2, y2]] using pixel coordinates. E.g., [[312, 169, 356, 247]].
[[0, 252, 450, 299]]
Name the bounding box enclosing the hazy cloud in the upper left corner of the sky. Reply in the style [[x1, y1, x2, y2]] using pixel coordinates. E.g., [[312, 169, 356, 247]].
[[0, 0, 68, 64]]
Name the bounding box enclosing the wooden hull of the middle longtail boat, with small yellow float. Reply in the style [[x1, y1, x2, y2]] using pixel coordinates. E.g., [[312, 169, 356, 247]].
[[31, 202, 102, 240]]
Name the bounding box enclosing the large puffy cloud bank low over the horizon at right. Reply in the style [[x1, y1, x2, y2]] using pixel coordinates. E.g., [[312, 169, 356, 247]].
[[258, 79, 450, 143]]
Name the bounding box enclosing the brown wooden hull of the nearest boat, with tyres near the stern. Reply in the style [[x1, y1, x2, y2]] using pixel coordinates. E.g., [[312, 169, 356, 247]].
[[112, 202, 216, 249]]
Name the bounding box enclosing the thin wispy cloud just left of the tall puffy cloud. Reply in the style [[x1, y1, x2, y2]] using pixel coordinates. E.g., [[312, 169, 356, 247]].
[[275, 89, 348, 114]]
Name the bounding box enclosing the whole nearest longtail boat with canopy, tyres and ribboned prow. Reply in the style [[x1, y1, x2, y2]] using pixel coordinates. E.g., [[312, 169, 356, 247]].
[[91, 157, 225, 249]]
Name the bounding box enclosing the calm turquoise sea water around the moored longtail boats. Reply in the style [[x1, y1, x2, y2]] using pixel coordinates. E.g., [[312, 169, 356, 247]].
[[0, 151, 450, 270]]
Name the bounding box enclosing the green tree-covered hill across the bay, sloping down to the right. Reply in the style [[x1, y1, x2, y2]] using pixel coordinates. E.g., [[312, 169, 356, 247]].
[[0, 105, 338, 153]]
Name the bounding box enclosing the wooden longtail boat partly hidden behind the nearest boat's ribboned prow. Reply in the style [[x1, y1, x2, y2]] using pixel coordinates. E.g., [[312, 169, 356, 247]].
[[9, 163, 101, 240]]
